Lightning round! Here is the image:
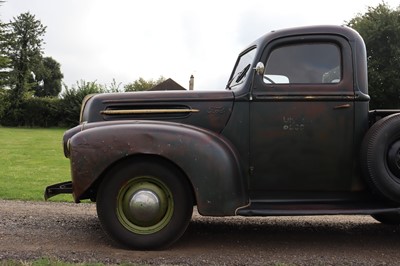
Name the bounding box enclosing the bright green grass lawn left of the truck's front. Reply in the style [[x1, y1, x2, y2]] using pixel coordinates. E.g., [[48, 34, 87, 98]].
[[0, 127, 72, 201]]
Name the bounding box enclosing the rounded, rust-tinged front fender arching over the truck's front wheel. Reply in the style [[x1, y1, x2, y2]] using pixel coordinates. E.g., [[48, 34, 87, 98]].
[[69, 121, 248, 215]]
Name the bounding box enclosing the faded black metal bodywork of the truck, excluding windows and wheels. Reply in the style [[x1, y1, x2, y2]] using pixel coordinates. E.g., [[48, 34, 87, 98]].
[[47, 26, 398, 215]]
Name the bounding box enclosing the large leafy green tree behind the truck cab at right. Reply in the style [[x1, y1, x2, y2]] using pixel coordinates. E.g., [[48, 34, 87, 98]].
[[348, 3, 400, 109]]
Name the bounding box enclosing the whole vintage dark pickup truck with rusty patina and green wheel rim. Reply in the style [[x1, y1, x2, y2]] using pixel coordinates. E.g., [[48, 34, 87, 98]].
[[45, 26, 400, 249]]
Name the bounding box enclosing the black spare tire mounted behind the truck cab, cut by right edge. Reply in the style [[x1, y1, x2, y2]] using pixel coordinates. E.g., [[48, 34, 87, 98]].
[[361, 114, 400, 203]]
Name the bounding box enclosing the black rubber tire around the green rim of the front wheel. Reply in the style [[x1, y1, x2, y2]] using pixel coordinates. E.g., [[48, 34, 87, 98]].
[[97, 162, 193, 249]]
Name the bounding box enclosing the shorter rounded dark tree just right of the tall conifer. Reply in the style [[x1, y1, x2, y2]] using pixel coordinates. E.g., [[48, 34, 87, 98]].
[[33, 57, 64, 97]]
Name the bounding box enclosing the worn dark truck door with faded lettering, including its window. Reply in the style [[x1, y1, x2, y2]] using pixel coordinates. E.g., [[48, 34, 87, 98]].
[[249, 35, 354, 196]]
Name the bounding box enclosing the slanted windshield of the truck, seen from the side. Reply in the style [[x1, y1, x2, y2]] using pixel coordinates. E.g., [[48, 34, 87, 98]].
[[226, 47, 256, 89]]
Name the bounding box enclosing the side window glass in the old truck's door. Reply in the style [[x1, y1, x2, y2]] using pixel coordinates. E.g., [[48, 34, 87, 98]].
[[264, 43, 342, 84]]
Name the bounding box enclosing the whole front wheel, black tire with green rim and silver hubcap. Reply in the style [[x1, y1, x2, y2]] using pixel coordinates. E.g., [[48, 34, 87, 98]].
[[96, 160, 193, 250]]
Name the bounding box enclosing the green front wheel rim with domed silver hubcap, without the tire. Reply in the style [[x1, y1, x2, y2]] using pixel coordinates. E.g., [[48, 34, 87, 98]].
[[117, 176, 174, 234]]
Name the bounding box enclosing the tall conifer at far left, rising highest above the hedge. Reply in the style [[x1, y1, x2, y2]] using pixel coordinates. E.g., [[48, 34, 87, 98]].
[[8, 12, 46, 105]]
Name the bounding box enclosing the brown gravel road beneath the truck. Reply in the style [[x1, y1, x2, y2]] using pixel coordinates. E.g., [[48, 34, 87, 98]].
[[0, 200, 400, 265]]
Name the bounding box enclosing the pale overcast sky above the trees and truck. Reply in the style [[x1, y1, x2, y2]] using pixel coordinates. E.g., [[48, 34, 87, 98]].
[[0, 0, 400, 90]]
